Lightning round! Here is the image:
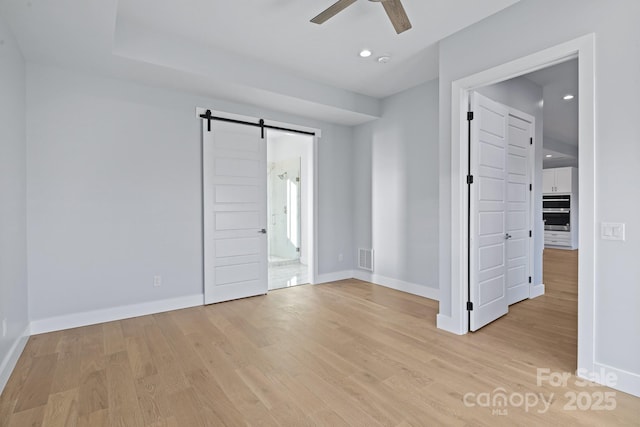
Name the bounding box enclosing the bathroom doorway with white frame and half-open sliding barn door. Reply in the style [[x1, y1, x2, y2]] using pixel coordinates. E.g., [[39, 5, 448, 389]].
[[196, 107, 321, 304]]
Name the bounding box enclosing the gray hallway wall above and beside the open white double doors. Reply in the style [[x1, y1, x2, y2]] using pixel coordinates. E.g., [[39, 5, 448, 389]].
[[478, 77, 544, 285]]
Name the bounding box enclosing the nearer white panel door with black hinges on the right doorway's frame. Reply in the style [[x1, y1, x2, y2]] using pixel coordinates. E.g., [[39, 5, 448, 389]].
[[469, 93, 509, 331]]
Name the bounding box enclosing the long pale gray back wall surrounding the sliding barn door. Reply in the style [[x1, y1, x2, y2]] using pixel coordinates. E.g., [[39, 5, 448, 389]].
[[27, 64, 353, 320]]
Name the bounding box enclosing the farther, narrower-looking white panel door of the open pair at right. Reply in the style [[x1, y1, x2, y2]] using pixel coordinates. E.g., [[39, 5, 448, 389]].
[[506, 112, 533, 305]]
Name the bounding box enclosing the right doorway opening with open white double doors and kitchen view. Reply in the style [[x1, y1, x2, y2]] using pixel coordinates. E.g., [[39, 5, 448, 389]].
[[468, 58, 579, 332]]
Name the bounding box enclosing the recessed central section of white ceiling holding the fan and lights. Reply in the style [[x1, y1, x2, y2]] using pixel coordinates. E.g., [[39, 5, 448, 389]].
[[118, 0, 516, 97]]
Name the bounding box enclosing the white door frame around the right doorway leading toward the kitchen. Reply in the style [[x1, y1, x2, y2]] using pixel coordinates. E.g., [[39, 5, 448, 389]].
[[438, 34, 596, 376]]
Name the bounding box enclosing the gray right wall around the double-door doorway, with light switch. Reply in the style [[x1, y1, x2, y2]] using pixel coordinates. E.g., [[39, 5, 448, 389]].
[[440, 0, 640, 382]]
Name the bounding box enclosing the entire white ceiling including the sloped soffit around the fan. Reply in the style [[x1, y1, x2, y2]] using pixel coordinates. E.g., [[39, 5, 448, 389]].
[[0, 0, 518, 124]]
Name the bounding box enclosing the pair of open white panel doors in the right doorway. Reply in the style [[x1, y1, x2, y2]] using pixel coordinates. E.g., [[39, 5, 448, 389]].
[[469, 93, 534, 331]]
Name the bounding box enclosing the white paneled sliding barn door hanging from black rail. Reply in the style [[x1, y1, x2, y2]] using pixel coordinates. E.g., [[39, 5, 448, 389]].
[[202, 120, 268, 304]]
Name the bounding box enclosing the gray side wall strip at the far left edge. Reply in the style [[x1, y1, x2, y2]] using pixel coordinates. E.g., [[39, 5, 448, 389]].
[[0, 19, 29, 390]]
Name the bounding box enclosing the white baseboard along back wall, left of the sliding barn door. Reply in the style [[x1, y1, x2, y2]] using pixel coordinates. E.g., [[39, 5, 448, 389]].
[[31, 294, 204, 335]]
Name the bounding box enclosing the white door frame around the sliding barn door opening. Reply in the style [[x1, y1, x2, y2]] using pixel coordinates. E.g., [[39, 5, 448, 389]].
[[196, 107, 322, 290]]
